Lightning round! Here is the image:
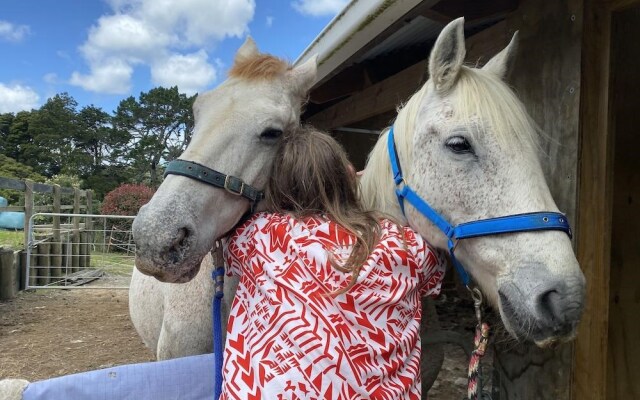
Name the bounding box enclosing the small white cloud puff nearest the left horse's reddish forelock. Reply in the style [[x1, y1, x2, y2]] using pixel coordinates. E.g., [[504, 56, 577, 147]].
[[151, 50, 216, 95]]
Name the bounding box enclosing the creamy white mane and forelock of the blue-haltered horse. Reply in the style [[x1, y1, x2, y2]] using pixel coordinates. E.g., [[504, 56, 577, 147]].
[[360, 66, 540, 219]]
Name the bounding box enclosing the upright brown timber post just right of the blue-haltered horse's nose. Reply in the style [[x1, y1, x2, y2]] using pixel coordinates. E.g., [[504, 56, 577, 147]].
[[571, 0, 613, 400]]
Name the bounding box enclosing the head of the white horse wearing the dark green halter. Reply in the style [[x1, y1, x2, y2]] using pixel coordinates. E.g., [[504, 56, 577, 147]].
[[133, 38, 316, 283]]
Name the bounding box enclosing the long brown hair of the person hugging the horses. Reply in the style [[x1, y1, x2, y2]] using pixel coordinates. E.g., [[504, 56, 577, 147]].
[[265, 127, 380, 295]]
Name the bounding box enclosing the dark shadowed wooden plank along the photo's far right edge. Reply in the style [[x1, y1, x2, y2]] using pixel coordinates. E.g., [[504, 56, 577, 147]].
[[607, 4, 640, 399]]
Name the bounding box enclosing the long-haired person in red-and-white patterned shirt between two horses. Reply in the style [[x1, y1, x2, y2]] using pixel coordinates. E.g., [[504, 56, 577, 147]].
[[221, 128, 444, 399]]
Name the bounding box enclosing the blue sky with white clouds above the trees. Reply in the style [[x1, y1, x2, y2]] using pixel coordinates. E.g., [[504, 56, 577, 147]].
[[0, 0, 348, 113]]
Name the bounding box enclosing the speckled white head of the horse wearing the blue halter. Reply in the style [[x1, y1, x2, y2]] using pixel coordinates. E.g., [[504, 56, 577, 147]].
[[362, 18, 585, 346]]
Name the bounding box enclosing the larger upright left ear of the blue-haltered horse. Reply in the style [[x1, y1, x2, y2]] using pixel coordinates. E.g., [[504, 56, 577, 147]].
[[429, 17, 467, 92]]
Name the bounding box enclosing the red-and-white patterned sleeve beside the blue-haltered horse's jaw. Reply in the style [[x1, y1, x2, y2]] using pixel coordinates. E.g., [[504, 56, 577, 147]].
[[404, 227, 446, 296]]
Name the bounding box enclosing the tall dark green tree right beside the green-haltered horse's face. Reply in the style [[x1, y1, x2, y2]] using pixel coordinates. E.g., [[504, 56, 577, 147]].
[[114, 86, 196, 187]]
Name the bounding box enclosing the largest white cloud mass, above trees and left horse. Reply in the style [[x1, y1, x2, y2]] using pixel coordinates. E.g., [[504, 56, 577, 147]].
[[70, 0, 255, 94]]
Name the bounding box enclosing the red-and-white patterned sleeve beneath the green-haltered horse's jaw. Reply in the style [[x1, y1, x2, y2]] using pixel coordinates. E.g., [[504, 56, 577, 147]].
[[224, 213, 267, 276]]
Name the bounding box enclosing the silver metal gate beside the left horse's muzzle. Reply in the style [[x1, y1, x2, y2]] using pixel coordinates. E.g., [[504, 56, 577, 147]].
[[25, 213, 135, 289]]
